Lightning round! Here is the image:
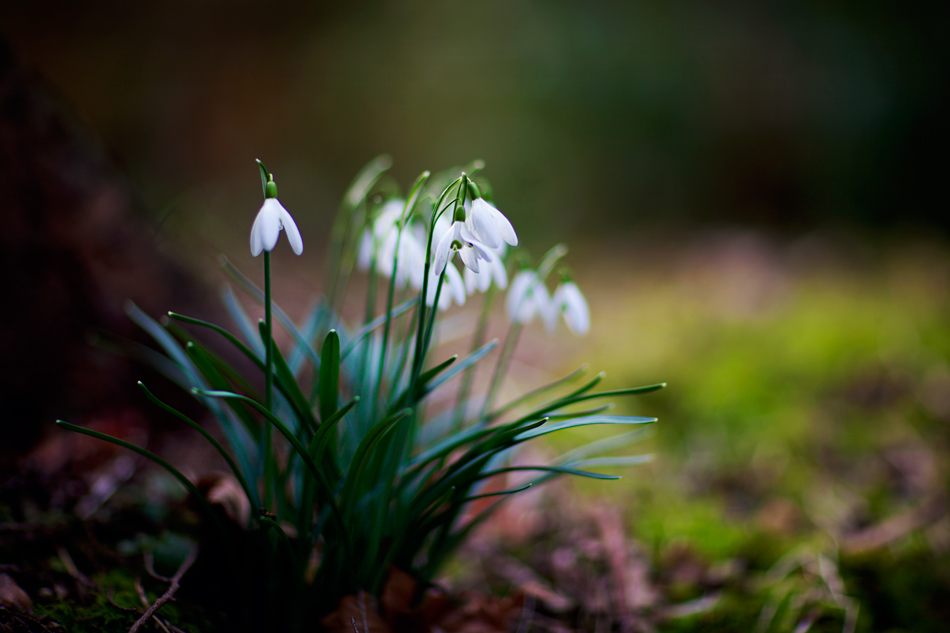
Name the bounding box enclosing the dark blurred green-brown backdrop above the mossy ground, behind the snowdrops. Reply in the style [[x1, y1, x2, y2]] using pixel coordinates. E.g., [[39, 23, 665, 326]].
[[0, 0, 950, 243]]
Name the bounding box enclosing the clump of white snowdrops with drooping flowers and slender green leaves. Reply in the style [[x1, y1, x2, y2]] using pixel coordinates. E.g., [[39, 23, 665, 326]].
[[60, 158, 663, 630]]
